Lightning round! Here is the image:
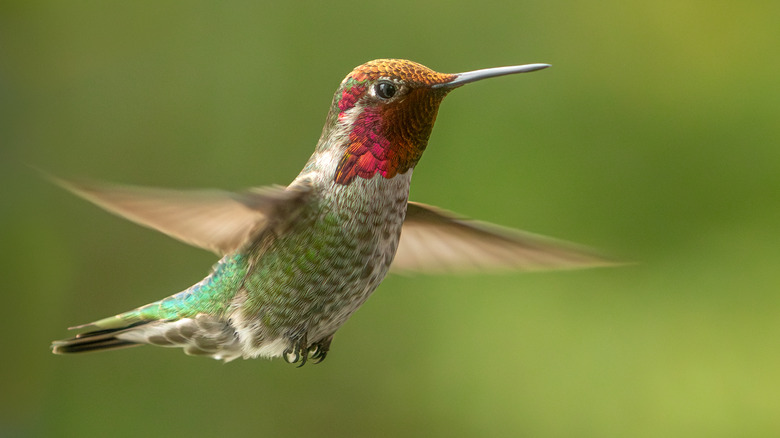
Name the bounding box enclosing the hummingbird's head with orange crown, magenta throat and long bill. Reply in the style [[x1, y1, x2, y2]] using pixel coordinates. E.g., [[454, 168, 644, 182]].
[[316, 59, 548, 185]]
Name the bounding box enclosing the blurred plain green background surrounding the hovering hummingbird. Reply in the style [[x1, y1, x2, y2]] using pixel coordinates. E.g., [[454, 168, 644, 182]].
[[0, 0, 780, 437]]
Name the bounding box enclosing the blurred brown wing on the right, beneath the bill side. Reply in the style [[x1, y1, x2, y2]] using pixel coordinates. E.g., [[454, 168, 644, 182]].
[[390, 202, 617, 273]]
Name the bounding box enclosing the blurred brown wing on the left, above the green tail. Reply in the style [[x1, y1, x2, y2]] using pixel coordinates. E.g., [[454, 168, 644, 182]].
[[51, 178, 306, 255]]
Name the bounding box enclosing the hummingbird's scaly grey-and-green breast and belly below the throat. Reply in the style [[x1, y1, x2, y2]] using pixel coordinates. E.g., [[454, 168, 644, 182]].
[[232, 170, 411, 354]]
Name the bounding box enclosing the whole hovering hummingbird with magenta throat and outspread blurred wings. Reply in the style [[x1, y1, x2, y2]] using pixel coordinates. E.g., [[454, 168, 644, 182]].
[[52, 59, 612, 366]]
